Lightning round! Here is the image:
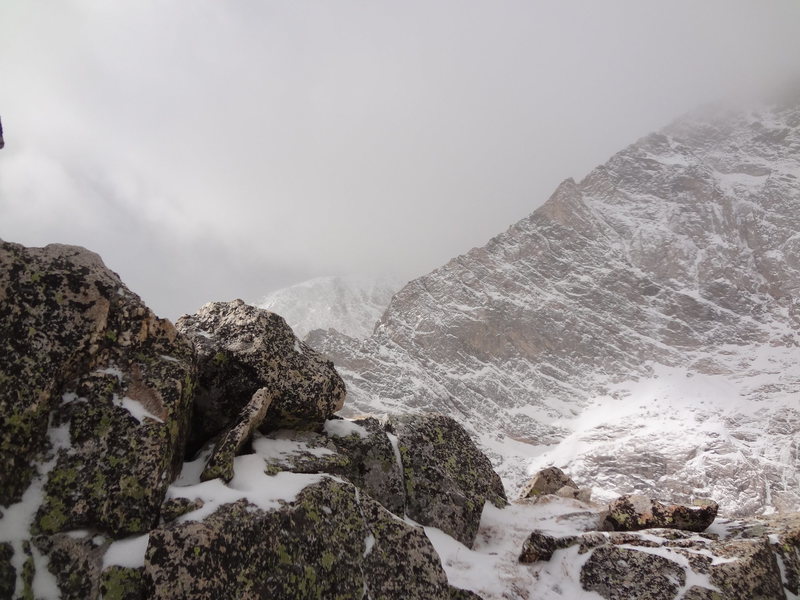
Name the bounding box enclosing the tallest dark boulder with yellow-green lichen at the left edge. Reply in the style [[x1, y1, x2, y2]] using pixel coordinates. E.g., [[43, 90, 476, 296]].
[[0, 242, 194, 535]]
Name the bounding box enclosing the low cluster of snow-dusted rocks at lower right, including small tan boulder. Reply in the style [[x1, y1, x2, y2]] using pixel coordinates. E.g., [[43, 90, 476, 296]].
[[506, 468, 800, 600]]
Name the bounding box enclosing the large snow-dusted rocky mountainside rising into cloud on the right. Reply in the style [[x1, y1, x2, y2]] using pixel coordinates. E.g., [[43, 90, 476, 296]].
[[309, 99, 800, 515]]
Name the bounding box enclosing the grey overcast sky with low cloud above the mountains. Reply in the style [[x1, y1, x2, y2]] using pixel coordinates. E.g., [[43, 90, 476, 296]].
[[0, 0, 800, 318]]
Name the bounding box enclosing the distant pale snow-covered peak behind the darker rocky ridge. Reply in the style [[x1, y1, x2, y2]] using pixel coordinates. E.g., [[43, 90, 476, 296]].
[[254, 275, 403, 339]]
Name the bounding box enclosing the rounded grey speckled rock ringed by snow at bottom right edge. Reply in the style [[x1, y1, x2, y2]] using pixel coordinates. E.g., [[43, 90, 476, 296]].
[[581, 546, 686, 600]]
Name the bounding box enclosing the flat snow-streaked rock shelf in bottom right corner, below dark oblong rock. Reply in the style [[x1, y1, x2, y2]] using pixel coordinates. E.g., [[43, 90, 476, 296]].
[[565, 514, 800, 600]]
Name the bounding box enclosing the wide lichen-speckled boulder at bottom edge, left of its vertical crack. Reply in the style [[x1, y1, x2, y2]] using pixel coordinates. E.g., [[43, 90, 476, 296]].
[[145, 479, 366, 600]]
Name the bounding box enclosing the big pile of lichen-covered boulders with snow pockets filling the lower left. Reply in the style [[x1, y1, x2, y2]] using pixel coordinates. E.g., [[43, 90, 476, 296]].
[[0, 243, 504, 600]]
